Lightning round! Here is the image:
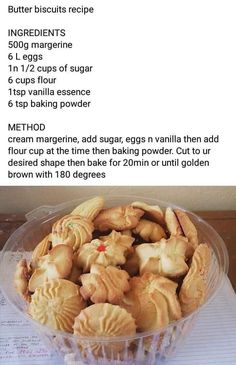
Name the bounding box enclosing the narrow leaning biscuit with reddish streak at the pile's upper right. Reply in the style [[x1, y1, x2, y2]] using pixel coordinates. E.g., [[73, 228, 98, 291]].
[[174, 209, 198, 250]]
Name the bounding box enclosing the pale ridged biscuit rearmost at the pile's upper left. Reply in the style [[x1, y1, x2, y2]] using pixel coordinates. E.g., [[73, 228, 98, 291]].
[[71, 196, 104, 221]]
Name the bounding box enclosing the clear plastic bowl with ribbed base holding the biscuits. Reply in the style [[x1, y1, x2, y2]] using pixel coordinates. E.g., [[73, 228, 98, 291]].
[[0, 195, 228, 365]]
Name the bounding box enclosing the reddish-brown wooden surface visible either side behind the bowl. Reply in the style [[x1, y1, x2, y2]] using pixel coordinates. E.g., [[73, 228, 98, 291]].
[[0, 210, 236, 291]]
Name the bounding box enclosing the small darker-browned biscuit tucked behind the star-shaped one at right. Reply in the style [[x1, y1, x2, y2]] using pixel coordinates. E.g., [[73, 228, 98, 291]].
[[133, 219, 166, 242]]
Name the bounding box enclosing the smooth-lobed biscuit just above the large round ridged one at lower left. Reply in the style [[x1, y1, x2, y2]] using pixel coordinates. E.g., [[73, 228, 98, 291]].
[[29, 245, 73, 292]]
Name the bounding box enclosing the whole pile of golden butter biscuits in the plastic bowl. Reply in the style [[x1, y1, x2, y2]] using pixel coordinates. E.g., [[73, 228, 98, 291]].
[[14, 196, 212, 352]]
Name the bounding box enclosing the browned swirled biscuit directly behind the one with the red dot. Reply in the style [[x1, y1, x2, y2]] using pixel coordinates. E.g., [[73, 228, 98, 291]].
[[94, 205, 144, 232]]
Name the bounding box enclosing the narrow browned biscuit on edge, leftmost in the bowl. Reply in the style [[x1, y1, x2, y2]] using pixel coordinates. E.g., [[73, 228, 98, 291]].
[[14, 259, 30, 301]]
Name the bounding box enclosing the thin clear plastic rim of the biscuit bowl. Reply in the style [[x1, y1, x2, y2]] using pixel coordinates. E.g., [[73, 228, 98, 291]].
[[0, 194, 229, 343]]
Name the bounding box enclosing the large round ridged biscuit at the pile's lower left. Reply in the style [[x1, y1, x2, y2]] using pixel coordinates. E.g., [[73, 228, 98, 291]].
[[29, 279, 85, 332]]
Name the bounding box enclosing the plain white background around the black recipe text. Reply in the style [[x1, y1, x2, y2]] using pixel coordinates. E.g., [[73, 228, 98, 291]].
[[0, 0, 236, 185]]
